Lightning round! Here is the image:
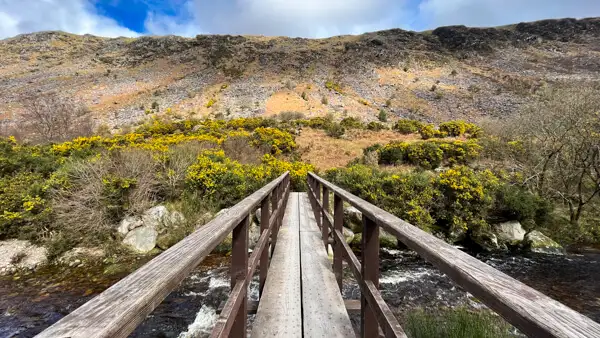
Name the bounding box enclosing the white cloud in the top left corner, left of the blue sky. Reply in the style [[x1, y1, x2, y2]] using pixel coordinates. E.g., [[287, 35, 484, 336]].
[[0, 0, 138, 38]]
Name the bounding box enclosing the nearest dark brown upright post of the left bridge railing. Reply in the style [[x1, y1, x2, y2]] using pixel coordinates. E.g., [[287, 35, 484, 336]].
[[230, 215, 250, 337]]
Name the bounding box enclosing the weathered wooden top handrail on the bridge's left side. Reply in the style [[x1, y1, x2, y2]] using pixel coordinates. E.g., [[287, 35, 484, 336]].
[[37, 172, 290, 338]]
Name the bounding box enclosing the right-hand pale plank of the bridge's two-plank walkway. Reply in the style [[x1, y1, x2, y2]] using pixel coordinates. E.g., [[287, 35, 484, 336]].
[[300, 194, 355, 337]]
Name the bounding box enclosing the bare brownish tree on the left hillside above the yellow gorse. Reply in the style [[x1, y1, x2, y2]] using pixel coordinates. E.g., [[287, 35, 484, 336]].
[[21, 93, 92, 142]]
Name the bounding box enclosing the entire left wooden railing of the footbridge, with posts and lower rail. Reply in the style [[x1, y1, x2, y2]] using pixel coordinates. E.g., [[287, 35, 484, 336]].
[[38, 173, 290, 338]]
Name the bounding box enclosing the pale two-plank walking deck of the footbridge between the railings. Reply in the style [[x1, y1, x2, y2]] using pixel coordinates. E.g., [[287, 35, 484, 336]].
[[252, 193, 355, 338]]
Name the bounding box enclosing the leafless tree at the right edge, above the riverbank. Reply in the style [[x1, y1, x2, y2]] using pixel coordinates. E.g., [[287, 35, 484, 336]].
[[507, 86, 600, 224]]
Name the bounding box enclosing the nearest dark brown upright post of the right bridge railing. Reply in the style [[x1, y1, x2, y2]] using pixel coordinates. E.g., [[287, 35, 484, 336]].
[[360, 214, 379, 338]]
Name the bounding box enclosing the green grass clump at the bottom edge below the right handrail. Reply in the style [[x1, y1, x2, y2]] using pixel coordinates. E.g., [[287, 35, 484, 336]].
[[404, 309, 514, 338]]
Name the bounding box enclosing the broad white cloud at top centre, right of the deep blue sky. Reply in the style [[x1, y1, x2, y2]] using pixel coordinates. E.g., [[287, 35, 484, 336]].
[[146, 0, 407, 37]]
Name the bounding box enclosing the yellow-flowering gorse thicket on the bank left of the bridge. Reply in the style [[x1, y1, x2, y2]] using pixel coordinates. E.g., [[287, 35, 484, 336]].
[[0, 118, 315, 257]]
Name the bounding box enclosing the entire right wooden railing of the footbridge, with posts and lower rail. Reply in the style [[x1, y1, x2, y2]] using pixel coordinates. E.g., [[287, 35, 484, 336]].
[[308, 173, 600, 338]]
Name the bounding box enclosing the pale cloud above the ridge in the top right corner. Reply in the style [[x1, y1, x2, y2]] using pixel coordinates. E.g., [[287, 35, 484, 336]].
[[419, 0, 600, 28]]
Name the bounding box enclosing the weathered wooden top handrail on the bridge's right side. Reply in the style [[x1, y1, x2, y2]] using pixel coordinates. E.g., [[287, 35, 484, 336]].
[[308, 173, 600, 338]]
